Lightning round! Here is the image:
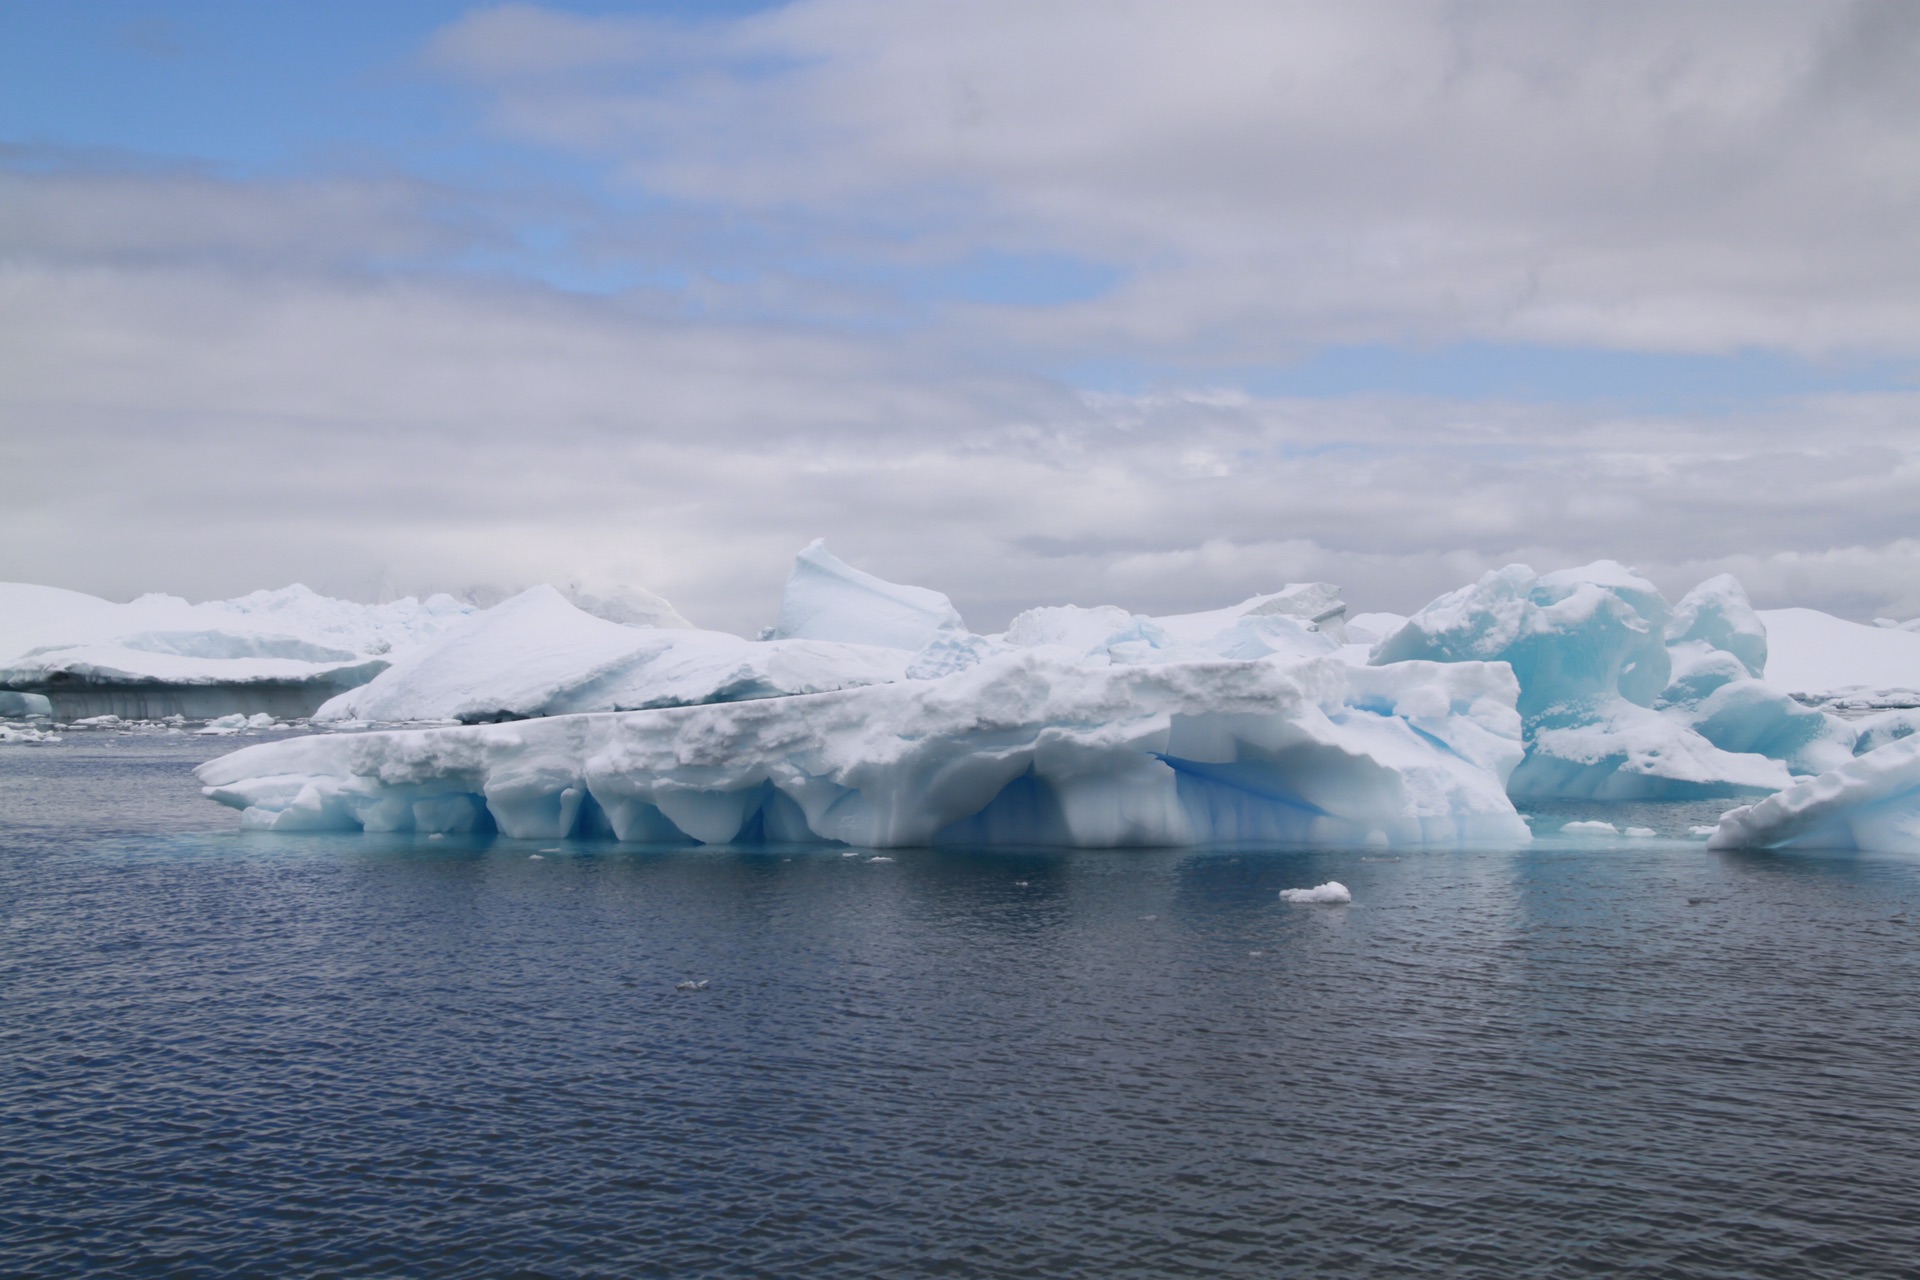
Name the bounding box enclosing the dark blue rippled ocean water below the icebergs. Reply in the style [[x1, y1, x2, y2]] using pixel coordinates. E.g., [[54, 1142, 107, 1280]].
[[0, 733, 1920, 1278]]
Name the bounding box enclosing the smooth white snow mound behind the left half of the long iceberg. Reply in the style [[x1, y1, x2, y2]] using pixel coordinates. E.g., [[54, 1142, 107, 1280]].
[[313, 580, 910, 723]]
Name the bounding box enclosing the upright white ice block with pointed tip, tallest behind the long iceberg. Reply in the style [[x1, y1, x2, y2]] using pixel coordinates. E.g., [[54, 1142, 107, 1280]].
[[774, 541, 966, 652]]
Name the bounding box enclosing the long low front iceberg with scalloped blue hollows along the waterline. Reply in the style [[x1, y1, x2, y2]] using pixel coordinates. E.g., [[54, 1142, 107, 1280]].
[[200, 651, 1528, 846]]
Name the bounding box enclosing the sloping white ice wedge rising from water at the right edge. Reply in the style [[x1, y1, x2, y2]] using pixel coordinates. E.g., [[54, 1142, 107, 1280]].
[[1707, 737, 1920, 854]]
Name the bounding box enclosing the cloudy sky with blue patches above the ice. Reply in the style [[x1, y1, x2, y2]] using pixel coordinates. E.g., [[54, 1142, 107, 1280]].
[[0, 0, 1920, 633]]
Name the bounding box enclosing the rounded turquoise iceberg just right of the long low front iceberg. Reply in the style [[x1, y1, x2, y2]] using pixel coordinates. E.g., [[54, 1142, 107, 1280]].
[[1369, 560, 1812, 800]]
